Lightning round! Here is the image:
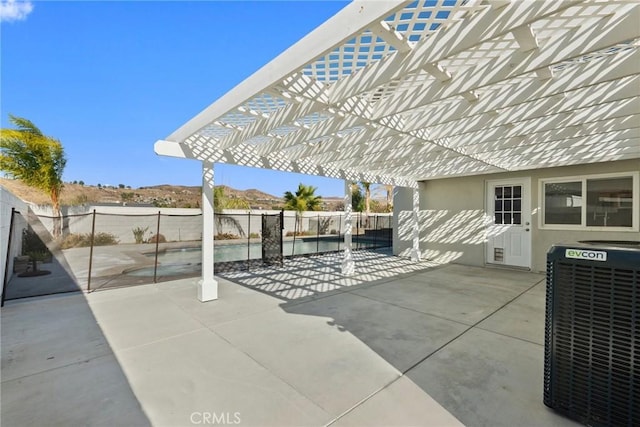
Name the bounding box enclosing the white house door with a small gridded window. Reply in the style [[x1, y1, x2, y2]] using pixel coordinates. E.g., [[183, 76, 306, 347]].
[[486, 178, 531, 268]]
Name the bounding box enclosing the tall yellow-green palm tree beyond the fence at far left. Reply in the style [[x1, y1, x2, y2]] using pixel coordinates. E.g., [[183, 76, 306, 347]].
[[0, 114, 67, 236]]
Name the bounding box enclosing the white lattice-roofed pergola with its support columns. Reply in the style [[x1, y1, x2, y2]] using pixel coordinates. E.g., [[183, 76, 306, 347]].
[[155, 0, 640, 301]]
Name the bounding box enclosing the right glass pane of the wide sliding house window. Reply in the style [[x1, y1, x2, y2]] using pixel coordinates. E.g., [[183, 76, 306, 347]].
[[587, 177, 633, 227]]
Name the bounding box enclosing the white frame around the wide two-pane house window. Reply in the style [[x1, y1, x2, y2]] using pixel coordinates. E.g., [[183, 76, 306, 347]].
[[538, 172, 640, 232]]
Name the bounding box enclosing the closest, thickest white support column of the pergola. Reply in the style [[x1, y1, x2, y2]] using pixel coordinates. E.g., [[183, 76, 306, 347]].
[[198, 162, 218, 302]]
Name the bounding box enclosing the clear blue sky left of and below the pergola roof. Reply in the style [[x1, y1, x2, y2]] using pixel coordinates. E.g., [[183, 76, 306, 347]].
[[0, 0, 346, 196]]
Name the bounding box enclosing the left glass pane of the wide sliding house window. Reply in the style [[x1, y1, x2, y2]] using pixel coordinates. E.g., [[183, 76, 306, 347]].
[[544, 181, 582, 225]]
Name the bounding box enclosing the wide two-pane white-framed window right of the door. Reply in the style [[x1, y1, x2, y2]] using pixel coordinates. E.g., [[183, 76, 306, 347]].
[[541, 173, 640, 230]]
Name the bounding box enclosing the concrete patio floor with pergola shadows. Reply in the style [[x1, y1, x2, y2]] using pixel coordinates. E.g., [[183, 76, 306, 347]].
[[1, 251, 573, 426]]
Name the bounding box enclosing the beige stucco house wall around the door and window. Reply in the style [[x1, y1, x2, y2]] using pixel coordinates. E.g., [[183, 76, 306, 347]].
[[394, 160, 640, 271]]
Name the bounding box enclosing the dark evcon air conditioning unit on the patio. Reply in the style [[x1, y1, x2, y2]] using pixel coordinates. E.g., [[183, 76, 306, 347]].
[[544, 241, 640, 427]]
